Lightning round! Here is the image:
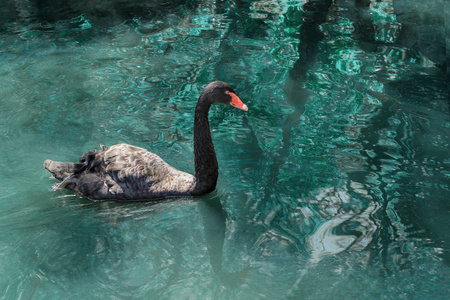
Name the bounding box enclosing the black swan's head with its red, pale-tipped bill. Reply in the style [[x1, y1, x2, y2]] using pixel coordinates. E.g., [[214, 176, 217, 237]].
[[202, 81, 248, 111]]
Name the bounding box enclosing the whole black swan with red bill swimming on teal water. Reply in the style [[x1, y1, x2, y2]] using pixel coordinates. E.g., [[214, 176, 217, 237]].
[[44, 81, 248, 200]]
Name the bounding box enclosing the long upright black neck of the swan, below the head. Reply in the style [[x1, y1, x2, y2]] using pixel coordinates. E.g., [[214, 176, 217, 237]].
[[192, 97, 219, 194]]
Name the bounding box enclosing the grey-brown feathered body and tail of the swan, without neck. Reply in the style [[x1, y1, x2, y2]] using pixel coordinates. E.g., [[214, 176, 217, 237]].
[[44, 144, 195, 200]]
